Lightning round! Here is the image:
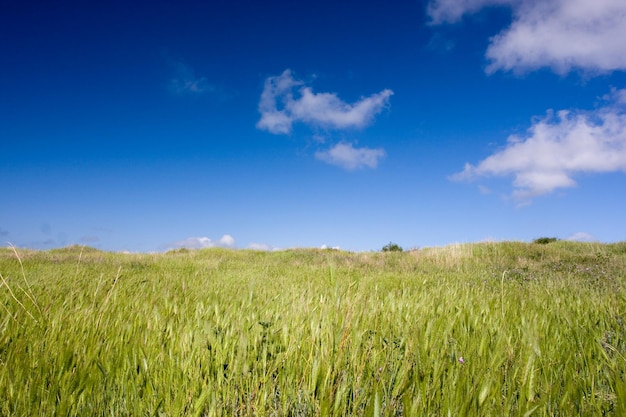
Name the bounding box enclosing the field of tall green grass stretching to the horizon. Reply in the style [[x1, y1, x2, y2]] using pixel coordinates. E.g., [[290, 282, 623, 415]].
[[0, 241, 626, 416]]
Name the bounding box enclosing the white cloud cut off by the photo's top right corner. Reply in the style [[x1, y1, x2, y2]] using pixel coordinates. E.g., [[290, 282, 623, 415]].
[[428, 0, 626, 74]]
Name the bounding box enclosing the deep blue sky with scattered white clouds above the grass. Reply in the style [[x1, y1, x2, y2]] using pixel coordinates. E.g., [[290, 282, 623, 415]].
[[0, 0, 626, 252]]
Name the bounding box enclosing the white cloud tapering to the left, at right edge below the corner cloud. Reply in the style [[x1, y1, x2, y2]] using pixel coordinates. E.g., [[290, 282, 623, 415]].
[[451, 90, 626, 204]]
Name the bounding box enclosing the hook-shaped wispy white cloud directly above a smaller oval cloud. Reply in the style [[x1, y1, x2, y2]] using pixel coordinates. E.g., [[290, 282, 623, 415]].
[[257, 69, 393, 134]]
